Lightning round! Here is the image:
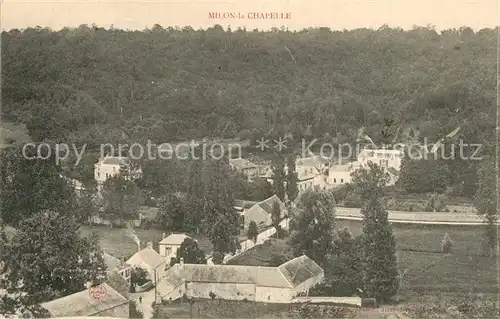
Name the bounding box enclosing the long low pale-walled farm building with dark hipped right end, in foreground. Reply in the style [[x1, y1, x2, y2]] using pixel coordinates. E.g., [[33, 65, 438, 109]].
[[157, 255, 324, 303]]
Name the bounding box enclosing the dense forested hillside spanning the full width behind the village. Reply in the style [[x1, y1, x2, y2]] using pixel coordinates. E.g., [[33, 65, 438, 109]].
[[2, 25, 496, 196]]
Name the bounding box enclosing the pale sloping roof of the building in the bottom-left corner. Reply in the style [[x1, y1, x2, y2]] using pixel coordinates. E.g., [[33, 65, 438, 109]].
[[41, 283, 128, 317]]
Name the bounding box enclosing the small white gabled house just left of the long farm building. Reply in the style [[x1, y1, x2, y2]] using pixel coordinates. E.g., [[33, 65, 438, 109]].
[[126, 242, 166, 284]]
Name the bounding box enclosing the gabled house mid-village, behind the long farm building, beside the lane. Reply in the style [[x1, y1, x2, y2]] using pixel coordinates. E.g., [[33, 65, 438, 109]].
[[240, 195, 286, 229]]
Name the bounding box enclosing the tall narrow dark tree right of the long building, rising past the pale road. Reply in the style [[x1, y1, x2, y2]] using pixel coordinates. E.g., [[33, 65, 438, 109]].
[[353, 163, 399, 302]]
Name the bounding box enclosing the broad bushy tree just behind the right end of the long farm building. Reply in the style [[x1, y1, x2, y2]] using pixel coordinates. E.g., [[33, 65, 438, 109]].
[[290, 189, 335, 267]]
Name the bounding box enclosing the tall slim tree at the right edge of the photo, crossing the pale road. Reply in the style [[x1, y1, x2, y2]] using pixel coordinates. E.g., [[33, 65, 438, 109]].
[[474, 158, 498, 256]]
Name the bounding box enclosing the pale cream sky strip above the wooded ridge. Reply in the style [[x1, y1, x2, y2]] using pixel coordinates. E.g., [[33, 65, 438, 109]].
[[0, 0, 500, 30]]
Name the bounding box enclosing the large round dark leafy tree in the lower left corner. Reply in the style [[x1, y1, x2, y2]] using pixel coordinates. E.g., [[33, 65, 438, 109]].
[[2, 211, 106, 305]]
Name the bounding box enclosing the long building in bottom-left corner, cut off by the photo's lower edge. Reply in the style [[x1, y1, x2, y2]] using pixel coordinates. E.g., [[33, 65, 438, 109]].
[[41, 283, 129, 318]]
